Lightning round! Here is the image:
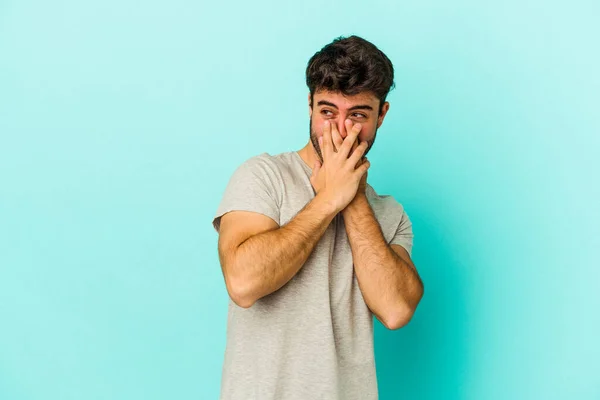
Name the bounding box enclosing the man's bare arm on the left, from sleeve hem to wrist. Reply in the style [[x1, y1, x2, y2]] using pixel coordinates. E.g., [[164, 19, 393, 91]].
[[219, 195, 337, 308]]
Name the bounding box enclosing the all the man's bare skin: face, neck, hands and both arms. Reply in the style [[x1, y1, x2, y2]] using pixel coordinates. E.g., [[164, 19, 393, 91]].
[[219, 87, 423, 329]]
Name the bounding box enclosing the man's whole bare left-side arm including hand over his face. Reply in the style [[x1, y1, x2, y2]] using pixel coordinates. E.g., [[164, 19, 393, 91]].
[[219, 104, 369, 308]]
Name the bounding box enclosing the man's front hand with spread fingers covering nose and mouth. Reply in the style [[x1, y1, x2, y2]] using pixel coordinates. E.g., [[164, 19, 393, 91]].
[[310, 121, 370, 213]]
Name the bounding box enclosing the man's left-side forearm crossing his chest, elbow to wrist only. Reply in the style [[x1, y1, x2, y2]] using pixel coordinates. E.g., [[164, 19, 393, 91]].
[[233, 195, 337, 307]]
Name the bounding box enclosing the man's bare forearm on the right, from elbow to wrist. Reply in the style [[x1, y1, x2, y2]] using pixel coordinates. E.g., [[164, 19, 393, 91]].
[[342, 193, 423, 329]]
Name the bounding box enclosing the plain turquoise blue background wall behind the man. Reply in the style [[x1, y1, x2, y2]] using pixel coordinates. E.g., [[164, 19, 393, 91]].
[[0, 0, 600, 400]]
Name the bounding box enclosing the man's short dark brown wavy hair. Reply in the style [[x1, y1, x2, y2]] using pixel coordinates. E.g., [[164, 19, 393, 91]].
[[306, 35, 395, 114]]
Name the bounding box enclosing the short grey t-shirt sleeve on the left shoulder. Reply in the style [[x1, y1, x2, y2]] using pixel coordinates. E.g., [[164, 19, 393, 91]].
[[212, 153, 281, 232]]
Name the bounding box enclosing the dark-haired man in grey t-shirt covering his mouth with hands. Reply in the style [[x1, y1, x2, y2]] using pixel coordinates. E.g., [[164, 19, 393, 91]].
[[213, 36, 423, 400]]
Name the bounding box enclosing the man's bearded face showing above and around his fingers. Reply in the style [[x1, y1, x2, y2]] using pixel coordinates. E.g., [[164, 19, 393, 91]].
[[308, 91, 389, 163]]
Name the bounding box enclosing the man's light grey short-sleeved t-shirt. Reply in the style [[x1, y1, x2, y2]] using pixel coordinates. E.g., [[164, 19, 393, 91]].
[[213, 151, 413, 400]]
